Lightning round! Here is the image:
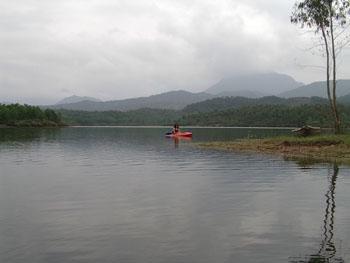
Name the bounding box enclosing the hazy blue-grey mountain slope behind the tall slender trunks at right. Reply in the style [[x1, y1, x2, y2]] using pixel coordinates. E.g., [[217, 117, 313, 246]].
[[278, 79, 350, 98]]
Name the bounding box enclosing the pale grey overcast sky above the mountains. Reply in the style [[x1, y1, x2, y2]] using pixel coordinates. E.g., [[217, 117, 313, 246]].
[[0, 0, 350, 104]]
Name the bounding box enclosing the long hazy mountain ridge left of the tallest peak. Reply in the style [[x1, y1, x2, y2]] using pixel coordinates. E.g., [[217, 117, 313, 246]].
[[50, 90, 214, 111]]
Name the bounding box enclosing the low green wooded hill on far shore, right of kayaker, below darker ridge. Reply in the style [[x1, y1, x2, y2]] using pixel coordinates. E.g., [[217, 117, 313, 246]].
[[178, 105, 344, 127]]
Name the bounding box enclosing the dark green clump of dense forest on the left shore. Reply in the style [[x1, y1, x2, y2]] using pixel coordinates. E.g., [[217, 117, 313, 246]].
[[0, 104, 62, 127]]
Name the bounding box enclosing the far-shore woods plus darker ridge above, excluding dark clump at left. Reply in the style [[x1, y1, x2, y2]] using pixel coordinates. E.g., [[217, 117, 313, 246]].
[[56, 96, 350, 127]]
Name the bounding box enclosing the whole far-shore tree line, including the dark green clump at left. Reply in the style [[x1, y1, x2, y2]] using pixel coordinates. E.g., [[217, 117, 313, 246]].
[[0, 104, 350, 128]]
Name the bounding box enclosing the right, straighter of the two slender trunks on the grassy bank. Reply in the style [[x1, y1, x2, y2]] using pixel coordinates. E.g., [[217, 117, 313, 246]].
[[328, 0, 341, 133]]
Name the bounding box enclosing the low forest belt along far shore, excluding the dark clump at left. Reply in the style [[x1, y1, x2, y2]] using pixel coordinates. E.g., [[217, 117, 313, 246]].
[[59, 104, 350, 127]]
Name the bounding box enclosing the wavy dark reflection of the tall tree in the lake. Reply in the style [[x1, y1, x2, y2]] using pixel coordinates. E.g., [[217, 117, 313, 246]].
[[290, 164, 345, 263]]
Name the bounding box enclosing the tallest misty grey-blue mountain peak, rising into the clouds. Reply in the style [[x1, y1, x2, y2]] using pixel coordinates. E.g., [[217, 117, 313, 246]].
[[205, 73, 303, 98]]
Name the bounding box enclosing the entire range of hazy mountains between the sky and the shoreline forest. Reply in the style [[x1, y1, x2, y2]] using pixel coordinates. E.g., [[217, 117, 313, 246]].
[[47, 73, 350, 111]]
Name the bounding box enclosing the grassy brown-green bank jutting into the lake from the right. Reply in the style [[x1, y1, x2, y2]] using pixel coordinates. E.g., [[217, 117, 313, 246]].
[[199, 135, 350, 164]]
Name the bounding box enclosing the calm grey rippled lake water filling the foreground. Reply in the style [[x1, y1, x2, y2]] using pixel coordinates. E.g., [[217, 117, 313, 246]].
[[0, 128, 350, 263]]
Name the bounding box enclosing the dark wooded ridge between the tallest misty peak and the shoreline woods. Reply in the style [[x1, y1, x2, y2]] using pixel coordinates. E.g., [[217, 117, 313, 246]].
[[183, 96, 328, 113]]
